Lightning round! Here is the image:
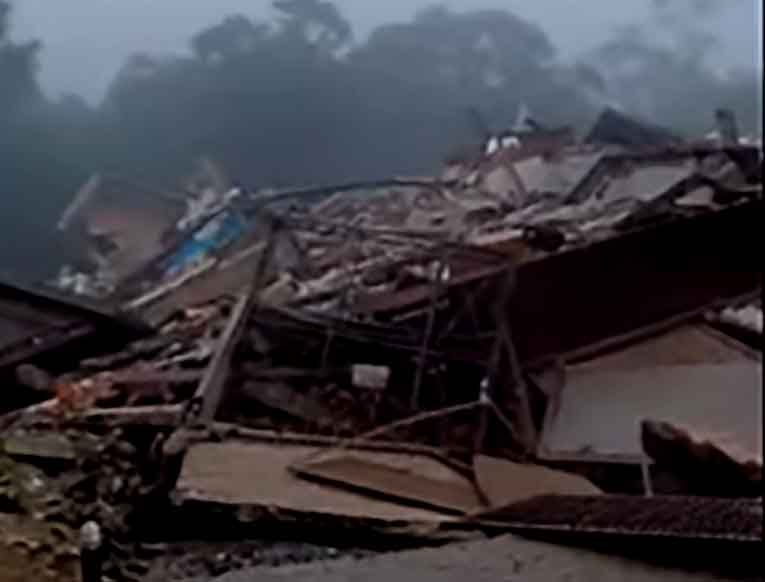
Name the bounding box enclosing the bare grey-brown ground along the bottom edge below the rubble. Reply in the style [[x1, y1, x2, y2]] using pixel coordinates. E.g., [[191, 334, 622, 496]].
[[194, 536, 752, 582]]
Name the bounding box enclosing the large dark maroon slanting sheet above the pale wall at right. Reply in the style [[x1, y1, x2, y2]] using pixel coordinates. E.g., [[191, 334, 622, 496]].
[[508, 200, 762, 363]]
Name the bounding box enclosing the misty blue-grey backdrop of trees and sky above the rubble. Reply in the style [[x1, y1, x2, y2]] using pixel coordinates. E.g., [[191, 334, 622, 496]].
[[0, 0, 762, 278]]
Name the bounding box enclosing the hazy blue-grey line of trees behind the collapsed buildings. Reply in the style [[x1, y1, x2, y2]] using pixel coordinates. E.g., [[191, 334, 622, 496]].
[[0, 0, 759, 277]]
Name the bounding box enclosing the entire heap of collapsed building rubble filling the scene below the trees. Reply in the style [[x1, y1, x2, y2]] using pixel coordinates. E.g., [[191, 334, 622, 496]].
[[0, 112, 762, 582]]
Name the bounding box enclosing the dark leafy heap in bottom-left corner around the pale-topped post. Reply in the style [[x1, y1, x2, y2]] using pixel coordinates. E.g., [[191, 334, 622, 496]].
[[0, 425, 162, 580]]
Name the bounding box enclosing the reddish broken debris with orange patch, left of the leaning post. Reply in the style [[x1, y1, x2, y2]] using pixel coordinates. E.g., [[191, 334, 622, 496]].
[[0, 298, 232, 426]]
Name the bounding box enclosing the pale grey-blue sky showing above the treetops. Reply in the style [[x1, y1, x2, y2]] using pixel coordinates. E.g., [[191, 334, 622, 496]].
[[11, 0, 762, 101]]
